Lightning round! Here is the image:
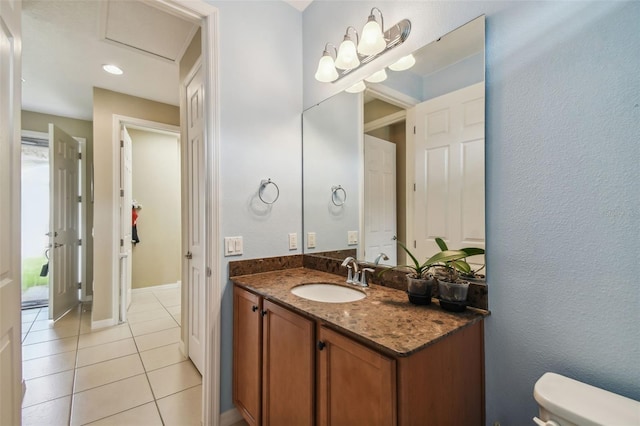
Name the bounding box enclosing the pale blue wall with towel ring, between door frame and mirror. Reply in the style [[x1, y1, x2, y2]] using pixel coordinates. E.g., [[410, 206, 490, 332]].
[[210, 1, 302, 412]]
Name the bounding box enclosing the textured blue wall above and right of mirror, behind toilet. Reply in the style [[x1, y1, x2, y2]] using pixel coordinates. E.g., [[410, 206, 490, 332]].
[[302, 0, 640, 425]]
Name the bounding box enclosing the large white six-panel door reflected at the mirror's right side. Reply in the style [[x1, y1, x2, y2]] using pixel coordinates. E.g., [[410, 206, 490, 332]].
[[414, 83, 485, 263]]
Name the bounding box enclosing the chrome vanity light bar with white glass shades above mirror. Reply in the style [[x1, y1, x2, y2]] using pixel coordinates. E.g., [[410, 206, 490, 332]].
[[315, 7, 411, 83]]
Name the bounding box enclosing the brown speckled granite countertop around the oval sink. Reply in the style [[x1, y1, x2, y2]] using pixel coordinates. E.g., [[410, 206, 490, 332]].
[[231, 268, 489, 357]]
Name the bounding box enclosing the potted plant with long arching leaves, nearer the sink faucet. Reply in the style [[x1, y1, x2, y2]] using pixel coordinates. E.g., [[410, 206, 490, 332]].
[[380, 236, 468, 305]]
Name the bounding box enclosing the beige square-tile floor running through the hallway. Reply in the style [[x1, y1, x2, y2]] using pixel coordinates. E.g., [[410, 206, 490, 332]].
[[22, 286, 202, 426]]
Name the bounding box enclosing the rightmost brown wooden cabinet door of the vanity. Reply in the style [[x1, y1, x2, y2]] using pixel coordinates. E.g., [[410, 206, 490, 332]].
[[318, 326, 397, 426]]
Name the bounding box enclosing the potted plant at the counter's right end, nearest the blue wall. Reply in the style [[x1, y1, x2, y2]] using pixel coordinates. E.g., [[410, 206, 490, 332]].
[[434, 238, 484, 311]]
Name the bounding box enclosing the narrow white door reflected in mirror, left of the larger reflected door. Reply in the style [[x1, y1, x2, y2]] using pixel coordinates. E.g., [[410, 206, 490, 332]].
[[364, 135, 398, 265]]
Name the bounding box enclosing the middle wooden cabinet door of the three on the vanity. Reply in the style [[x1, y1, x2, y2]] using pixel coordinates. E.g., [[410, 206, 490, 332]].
[[262, 301, 315, 426]]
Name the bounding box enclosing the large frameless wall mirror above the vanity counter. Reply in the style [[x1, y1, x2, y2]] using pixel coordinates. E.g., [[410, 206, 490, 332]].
[[303, 16, 485, 265]]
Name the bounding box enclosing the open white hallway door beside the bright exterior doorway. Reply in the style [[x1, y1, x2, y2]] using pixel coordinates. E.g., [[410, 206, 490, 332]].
[[49, 124, 80, 320]]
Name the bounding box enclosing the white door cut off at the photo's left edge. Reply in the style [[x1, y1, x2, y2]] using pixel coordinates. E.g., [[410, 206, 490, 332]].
[[0, 0, 22, 425]]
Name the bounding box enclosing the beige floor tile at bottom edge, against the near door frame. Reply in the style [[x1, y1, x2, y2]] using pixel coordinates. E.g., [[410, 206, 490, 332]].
[[158, 386, 202, 426]]
